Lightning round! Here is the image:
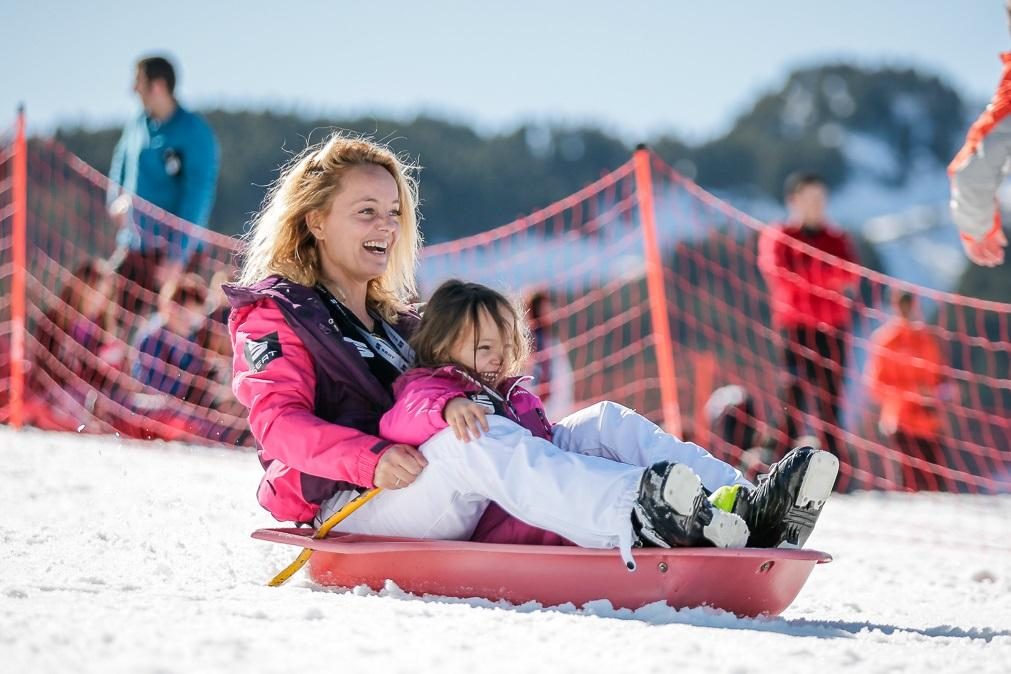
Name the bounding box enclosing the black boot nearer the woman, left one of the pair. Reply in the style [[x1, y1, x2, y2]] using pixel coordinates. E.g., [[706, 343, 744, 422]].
[[632, 461, 748, 548]]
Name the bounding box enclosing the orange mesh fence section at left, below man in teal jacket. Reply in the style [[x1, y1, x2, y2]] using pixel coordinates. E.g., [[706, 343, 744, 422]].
[[0, 133, 250, 446]]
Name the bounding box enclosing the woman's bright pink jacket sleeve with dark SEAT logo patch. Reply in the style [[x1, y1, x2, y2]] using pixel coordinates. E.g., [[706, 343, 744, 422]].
[[228, 300, 390, 488]]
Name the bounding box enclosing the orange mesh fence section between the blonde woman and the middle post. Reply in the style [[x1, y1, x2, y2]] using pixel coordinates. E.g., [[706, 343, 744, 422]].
[[421, 162, 661, 420]]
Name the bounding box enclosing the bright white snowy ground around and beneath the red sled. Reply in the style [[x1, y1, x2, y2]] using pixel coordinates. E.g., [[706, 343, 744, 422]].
[[0, 427, 1011, 674]]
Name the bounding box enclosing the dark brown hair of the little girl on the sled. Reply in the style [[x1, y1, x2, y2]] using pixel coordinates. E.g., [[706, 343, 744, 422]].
[[410, 279, 530, 375]]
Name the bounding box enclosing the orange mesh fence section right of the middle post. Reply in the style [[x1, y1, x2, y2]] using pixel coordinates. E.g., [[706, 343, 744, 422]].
[[654, 154, 1011, 492]]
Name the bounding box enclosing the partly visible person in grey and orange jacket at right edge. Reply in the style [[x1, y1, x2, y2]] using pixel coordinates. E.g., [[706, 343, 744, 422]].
[[948, 0, 1011, 267]]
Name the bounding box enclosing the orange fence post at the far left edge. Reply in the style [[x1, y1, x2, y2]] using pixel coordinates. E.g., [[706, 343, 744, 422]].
[[10, 104, 28, 428]]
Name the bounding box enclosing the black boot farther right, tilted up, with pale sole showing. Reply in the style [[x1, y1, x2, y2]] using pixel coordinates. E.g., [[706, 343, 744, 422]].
[[731, 447, 839, 548]]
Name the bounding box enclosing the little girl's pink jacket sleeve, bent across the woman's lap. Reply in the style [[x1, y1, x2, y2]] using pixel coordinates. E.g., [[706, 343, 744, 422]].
[[379, 376, 466, 447]]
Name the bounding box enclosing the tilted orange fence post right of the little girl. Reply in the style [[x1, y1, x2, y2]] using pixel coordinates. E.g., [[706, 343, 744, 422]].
[[634, 146, 681, 438]]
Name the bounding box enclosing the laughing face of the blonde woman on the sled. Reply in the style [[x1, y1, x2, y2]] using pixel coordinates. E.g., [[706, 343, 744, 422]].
[[308, 165, 400, 286]]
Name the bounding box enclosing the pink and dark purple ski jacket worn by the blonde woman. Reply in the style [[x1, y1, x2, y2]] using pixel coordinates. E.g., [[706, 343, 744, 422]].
[[224, 276, 420, 521]]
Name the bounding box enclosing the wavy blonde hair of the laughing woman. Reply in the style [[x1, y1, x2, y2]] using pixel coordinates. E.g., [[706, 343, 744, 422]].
[[239, 131, 422, 321]]
